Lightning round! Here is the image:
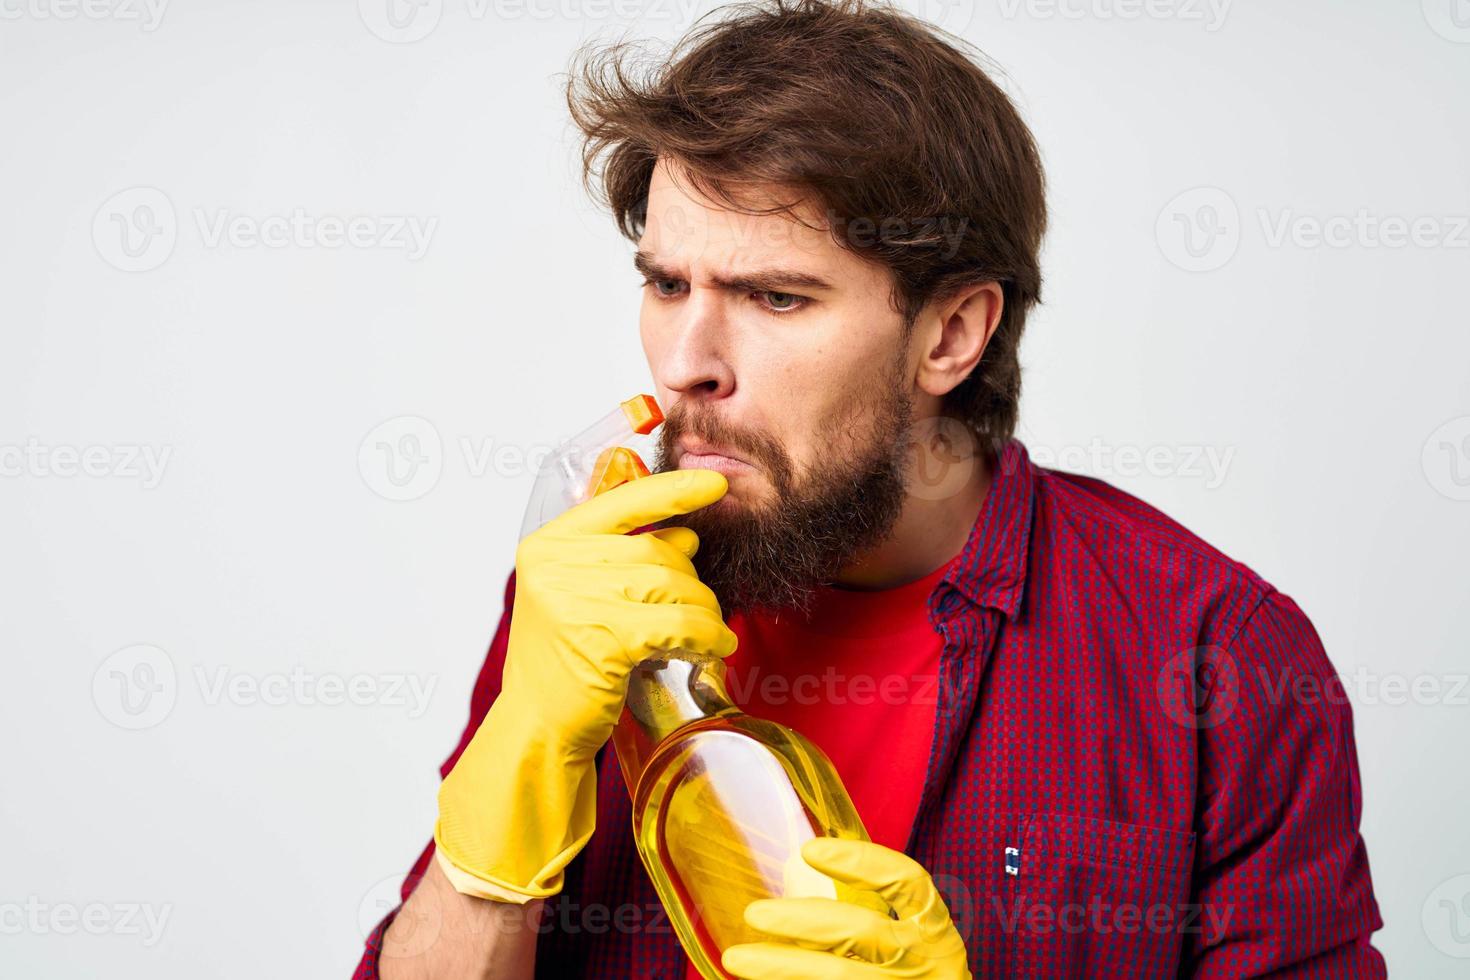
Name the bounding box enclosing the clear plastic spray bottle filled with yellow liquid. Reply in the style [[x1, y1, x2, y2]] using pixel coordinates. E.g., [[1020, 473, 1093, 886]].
[[522, 395, 888, 980]]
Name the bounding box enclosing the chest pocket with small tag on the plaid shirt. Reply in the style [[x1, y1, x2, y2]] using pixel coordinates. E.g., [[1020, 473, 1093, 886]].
[[997, 813, 1200, 979]]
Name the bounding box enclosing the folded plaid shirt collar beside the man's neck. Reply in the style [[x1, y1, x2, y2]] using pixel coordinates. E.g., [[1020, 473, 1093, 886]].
[[939, 438, 1036, 619]]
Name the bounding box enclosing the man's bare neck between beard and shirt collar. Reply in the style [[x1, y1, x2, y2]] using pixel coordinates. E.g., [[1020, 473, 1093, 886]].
[[836, 434, 992, 591]]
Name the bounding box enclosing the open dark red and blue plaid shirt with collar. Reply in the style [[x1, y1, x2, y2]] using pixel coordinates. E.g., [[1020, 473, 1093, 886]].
[[356, 439, 1386, 980]]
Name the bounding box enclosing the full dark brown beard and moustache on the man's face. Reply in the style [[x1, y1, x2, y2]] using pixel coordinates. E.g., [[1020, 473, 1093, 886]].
[[654, 359, 913, 617]]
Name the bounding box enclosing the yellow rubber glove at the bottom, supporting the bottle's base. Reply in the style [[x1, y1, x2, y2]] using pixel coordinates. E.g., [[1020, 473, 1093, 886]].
[[720, 837, 970, 980]]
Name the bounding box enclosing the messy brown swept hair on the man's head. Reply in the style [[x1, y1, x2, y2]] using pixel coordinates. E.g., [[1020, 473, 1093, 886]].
[[566, 0, 1047, 445]]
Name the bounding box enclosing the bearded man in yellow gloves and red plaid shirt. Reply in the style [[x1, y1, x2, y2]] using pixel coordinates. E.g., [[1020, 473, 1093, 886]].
[[359, 0, 1385, 980]]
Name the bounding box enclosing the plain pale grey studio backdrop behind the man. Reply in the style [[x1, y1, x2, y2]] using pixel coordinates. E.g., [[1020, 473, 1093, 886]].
[[0, 0, 1470, 977]]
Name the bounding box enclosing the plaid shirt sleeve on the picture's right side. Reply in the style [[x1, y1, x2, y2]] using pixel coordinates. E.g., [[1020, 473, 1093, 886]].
[[1180, 591, 1388, 979]]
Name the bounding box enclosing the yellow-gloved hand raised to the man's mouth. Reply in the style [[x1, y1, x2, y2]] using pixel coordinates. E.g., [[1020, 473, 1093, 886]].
[[434, 470, 735, 904]]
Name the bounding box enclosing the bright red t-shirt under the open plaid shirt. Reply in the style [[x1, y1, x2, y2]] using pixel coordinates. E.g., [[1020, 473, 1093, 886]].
[[686, 566, 948, 980]]
